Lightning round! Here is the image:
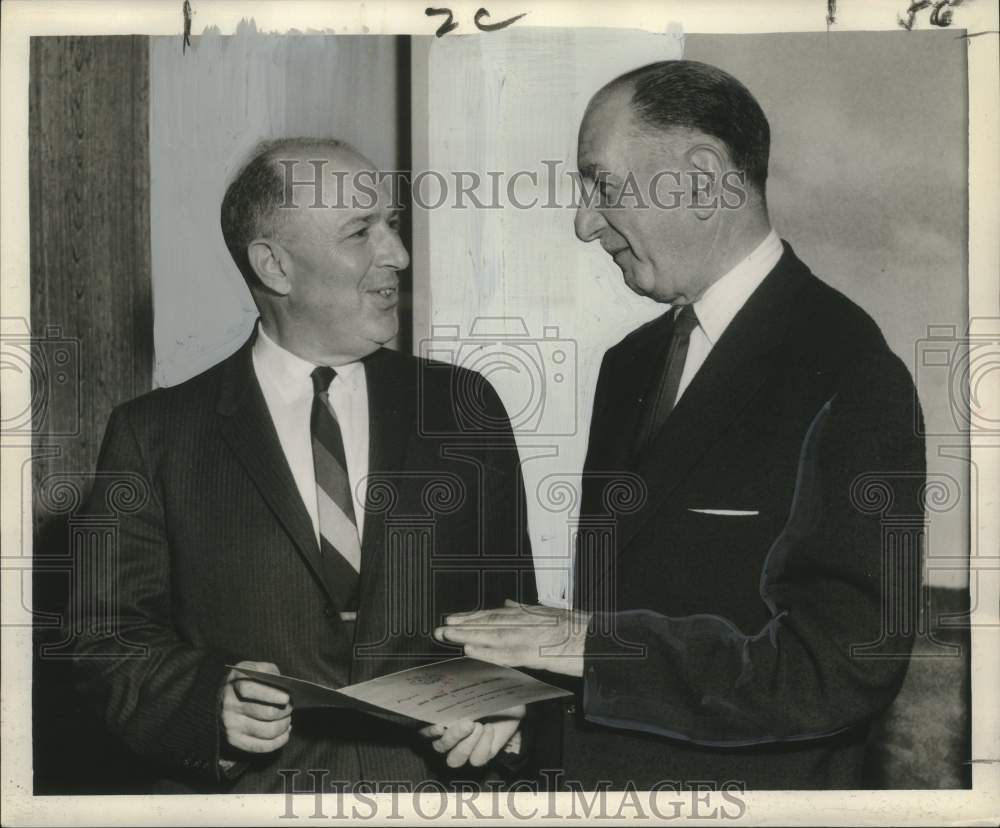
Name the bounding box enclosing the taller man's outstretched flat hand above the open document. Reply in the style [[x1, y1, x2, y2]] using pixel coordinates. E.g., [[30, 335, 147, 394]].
[[434, 600, 590, 676]]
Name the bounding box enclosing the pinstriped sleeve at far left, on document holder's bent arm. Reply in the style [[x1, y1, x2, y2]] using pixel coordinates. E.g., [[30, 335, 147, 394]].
[[70, 407, 239, 780]]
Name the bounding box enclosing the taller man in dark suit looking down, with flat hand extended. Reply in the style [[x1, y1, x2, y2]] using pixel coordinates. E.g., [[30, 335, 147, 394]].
[[437, 61, 925, 789]]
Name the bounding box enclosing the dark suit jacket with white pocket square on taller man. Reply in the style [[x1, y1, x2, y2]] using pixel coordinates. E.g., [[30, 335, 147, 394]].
[[564, 245, 925, 788]]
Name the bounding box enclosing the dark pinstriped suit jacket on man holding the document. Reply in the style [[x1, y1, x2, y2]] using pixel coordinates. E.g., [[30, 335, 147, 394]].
[[72, 339, 535, 792]]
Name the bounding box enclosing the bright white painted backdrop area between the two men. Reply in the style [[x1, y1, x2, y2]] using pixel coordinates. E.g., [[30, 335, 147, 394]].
[[413, 29, 682, 604]]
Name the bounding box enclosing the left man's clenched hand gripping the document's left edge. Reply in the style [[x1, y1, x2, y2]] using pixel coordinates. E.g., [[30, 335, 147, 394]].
[[222, 661, 292, 753]]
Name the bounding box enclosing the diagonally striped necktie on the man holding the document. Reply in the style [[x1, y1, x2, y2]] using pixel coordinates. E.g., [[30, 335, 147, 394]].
[[309, 365, 361, 611]]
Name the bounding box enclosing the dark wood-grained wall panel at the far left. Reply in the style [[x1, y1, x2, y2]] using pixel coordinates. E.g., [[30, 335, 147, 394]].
[[29, 37, 153, 529]]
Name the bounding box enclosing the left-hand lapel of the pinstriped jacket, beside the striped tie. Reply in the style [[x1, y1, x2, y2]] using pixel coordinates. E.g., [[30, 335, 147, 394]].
[[216, 337, 333, 602]]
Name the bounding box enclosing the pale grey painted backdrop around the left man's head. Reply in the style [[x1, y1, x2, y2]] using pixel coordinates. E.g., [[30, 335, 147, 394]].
[[149, 24, 399, 385]]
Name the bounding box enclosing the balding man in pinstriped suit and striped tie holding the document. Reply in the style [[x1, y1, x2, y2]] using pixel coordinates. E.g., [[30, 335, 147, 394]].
[[74, 139, 535, 793]]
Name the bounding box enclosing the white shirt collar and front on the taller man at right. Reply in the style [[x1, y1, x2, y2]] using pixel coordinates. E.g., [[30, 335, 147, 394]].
[[675, 230, 783, 404]]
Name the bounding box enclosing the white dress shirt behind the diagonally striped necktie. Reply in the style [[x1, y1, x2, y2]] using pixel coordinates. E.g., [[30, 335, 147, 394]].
[[253, 327, 368, 543]]
